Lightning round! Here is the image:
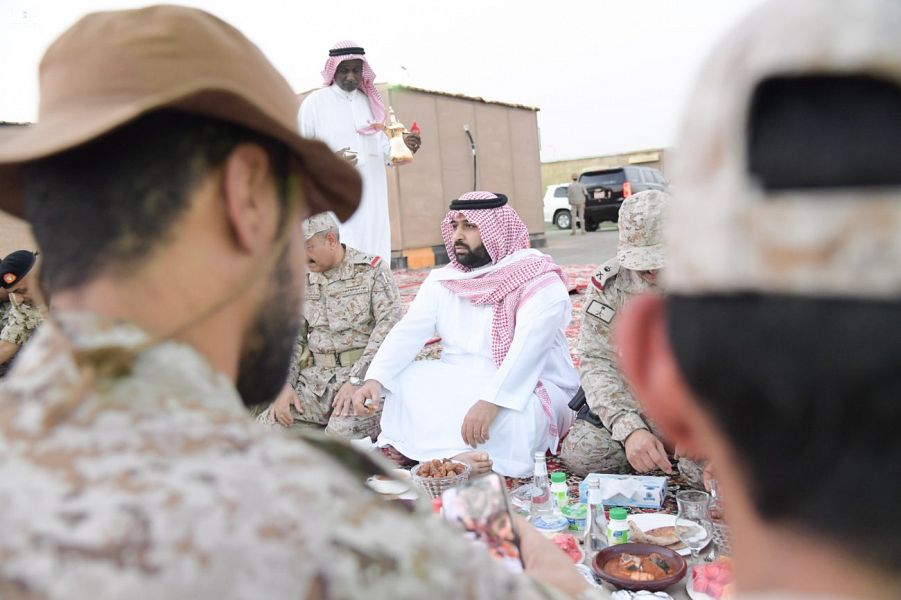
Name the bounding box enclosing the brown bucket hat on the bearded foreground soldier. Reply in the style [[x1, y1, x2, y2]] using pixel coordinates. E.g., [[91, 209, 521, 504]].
[[0, 6, 362, 220]]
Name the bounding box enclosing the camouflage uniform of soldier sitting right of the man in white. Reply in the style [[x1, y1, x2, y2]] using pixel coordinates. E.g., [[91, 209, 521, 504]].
[[560, 259, 703, 487]]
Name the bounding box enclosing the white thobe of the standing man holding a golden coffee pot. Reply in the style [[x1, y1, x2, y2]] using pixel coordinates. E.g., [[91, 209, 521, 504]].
[[298, 84, 391, 263]]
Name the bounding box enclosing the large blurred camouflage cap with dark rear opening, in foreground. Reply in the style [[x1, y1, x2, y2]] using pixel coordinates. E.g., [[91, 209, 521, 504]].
[[664, 0, 901, 299]]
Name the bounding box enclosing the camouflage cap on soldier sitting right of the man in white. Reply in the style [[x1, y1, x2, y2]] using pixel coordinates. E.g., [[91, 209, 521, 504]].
[[616, 190, 670, 271]]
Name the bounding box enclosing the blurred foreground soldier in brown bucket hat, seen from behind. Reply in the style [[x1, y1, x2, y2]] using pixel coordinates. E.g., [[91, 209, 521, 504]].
[[0, 6, 604, 598]]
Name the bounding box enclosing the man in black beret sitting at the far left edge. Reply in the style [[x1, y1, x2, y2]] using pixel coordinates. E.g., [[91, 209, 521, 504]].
[[0, 250, 44, 377]]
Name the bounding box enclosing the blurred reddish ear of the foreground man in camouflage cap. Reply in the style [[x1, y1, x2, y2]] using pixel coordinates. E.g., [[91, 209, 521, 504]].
[[614, 295, 703, 455]]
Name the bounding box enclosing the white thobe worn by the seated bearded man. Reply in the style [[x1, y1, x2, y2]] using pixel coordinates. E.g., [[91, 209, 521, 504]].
[[366, 250, 579, 477]]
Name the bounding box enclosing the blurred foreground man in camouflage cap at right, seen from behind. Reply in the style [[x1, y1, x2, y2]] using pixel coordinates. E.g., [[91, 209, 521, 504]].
[[617, 0, 901, 600]]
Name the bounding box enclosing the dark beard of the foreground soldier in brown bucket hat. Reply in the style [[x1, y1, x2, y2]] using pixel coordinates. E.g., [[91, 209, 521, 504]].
[[237, 248, 301, 407]]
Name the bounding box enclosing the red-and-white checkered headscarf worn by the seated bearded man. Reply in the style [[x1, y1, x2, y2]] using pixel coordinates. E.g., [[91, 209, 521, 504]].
[[441, 192, 566, 437]]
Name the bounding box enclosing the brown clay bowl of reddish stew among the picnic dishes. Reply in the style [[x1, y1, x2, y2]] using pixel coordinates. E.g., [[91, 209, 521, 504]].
[[592, 544, 687, 592]]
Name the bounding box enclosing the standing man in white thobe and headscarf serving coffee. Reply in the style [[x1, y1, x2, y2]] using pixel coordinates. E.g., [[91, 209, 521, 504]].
[[300, 41, 422, 266]]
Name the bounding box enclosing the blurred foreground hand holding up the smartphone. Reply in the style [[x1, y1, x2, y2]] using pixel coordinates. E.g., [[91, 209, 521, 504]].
[[515, 516, 588, 597]]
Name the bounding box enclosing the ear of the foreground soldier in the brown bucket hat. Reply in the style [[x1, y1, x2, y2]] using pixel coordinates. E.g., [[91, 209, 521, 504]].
[[222, 143, 278, 252]]
